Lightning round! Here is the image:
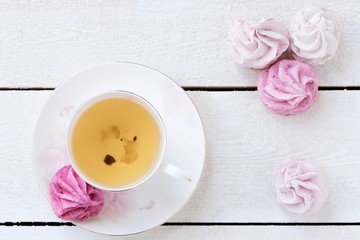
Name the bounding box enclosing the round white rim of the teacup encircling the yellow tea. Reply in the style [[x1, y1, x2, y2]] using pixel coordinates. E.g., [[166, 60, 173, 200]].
[[66, 90, 166, 192]]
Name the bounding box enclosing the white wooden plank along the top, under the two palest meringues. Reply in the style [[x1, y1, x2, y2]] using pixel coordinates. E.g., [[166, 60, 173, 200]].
[[0, 0, 360, 87]]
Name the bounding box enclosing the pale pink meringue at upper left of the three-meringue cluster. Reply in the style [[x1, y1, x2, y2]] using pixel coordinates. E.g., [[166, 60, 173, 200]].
[[228, 18, 289, 69]]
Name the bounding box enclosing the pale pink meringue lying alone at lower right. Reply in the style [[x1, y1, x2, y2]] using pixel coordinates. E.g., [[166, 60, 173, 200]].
[[274, 160, 329, 214]]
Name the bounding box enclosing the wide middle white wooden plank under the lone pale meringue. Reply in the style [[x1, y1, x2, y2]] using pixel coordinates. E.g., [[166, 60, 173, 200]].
[[0, 91, 360, 222]]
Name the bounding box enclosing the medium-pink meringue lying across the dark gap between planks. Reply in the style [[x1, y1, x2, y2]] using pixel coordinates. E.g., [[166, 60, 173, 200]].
[[258, 59, 318, 115]]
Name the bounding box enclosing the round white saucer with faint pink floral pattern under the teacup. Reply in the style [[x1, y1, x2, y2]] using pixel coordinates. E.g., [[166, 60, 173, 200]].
[[32, 63, 205, 235]]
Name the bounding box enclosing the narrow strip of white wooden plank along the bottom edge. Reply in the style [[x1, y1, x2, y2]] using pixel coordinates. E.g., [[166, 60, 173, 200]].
[[0, 226, 360, 240]]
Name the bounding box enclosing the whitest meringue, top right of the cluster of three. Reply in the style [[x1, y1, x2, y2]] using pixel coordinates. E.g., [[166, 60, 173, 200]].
[[290, 7, 340, 65]]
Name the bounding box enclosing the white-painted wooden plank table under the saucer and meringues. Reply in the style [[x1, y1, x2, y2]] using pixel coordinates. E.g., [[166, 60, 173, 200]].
[[0, 0, 360, 239]]
